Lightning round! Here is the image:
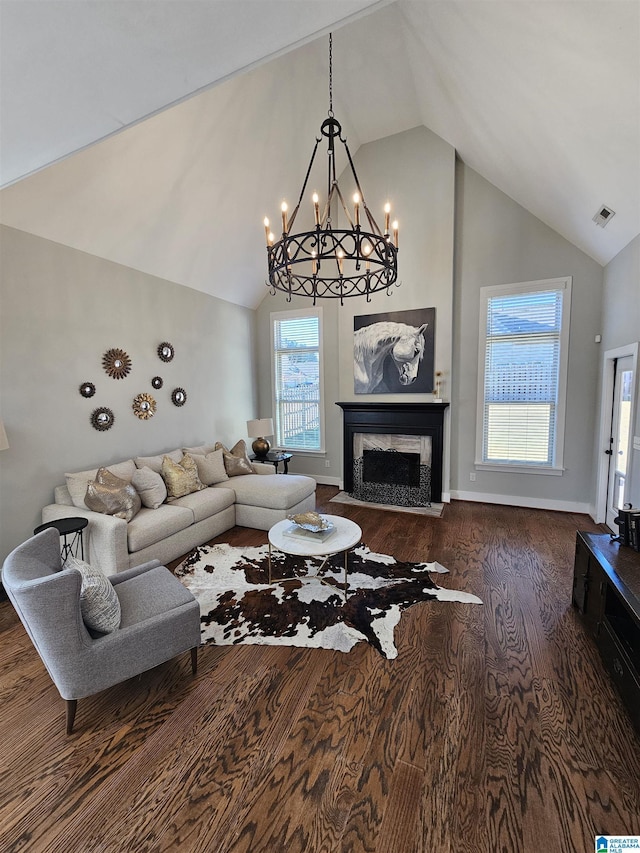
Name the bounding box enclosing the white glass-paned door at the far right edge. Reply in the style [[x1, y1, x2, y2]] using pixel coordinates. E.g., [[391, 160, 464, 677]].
[[605, 355, 633, 532]]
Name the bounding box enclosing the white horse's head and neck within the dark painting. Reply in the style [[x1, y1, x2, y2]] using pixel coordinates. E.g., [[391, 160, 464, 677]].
[[353, 321, 429, 394]]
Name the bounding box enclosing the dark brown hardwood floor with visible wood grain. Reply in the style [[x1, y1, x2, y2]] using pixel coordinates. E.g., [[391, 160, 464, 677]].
[[0, 486, 640, 853]]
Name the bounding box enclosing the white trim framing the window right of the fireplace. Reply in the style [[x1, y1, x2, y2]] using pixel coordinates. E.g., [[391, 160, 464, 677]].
[[474, 276, 573, 477]]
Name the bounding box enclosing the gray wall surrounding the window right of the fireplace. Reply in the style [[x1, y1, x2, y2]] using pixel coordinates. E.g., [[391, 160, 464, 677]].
[[451, 161, 603, 512]]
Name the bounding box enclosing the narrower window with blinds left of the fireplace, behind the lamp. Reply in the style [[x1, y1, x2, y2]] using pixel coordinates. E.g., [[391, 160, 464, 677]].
[[271, 308, 324, 451]]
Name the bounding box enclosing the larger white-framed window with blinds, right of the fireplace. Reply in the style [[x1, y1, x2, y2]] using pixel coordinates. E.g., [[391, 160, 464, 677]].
[[476, 278, 571, 474]]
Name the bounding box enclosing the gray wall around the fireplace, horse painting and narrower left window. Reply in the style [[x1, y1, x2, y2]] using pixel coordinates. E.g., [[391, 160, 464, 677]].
[[257, 127, 455, 492]]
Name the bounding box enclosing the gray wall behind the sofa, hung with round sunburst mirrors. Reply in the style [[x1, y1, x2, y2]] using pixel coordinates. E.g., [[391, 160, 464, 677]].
[[0, 227, 257, 560]]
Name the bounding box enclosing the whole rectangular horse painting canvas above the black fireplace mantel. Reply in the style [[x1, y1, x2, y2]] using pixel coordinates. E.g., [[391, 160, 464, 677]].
[[353, 308, 436, 394]]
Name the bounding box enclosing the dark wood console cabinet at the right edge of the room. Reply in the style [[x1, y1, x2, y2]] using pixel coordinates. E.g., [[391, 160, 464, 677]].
[[573, 532, 640, 732]]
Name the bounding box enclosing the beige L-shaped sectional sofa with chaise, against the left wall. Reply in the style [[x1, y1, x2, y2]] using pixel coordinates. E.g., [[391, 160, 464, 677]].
[[42, 445, 316, 574]]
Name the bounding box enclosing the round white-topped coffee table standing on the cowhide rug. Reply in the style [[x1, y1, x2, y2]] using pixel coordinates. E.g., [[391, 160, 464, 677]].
[[269, 513, 362, 599]]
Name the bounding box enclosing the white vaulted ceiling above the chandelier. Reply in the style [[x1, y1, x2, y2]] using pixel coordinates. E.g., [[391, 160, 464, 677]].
[[0, 0, 640, 307]]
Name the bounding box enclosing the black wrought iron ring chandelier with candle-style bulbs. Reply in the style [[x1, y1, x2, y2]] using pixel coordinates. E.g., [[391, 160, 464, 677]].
[[264, 35, 398, 305]]
